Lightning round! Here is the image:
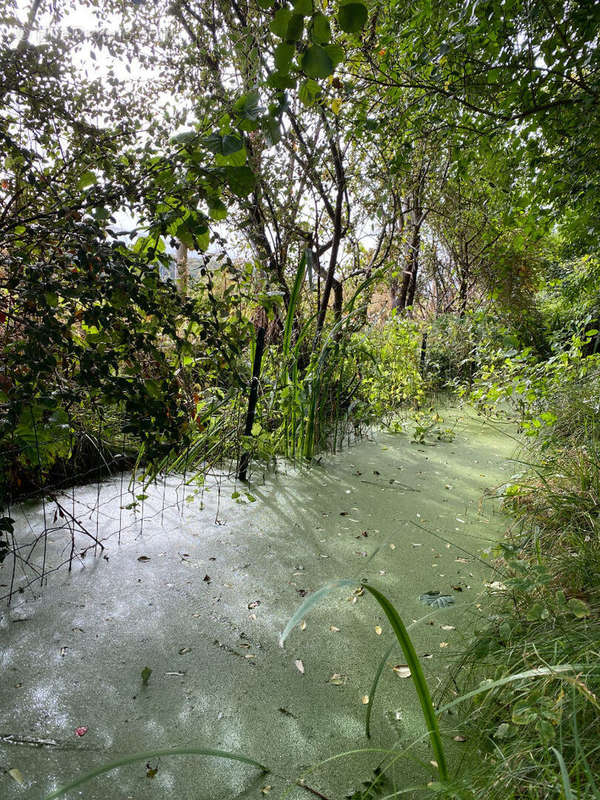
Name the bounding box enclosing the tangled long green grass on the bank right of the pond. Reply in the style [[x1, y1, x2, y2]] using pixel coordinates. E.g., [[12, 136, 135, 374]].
[[442, 404, 600, 800]]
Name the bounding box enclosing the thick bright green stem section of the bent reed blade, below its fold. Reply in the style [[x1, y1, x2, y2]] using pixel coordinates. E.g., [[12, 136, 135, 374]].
[[363, 583, 448, 781]]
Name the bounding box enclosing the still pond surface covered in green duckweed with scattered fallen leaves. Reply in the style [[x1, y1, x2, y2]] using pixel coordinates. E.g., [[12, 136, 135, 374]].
[[0, 411, 514, 800]]
